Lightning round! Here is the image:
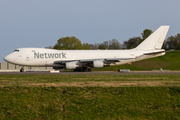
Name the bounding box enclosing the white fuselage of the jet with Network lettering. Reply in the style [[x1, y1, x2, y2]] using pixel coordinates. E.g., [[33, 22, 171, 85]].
[[4, 48, 164, 67]]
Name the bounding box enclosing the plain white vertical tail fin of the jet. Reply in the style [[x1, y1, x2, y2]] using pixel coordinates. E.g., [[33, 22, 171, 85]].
[[134, 26, 169, 50]]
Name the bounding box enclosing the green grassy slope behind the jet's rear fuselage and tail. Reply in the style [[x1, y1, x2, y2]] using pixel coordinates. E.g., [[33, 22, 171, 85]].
[[93, 50, 180, 71]]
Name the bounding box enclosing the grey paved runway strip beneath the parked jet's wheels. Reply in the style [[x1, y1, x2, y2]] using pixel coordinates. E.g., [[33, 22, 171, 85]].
[[0, 71, 180, 75]]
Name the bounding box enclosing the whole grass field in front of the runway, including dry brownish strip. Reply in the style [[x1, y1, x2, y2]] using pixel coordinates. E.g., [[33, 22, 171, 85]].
[[0, 74, 180, 120]]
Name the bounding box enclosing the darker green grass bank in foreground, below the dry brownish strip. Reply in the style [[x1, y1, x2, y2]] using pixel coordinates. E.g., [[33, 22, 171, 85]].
[[0, 86, 180, 120]]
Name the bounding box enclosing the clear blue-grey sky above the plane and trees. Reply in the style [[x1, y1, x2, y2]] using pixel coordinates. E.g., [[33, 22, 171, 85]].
[[0, 0, 180, 62]]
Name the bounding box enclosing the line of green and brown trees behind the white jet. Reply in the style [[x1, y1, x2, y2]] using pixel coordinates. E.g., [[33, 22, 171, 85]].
[[47, 29, 180, 50]]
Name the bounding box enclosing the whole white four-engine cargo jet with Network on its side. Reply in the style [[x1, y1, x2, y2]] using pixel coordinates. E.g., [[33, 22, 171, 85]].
[[4, 26, 169, 72]]
